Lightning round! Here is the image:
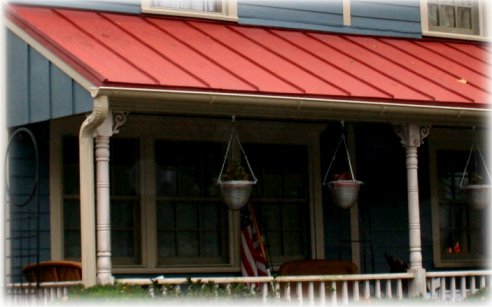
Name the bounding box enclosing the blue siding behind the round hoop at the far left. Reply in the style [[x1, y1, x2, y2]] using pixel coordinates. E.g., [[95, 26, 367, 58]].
[[6, 122, 51, 282]]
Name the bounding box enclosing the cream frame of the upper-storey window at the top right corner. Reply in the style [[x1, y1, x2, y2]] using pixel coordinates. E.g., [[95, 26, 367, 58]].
[[420, 0, 490, 41]]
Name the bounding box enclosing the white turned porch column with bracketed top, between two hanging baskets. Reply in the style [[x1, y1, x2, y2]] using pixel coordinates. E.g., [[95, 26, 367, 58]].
[[395, 123, 430, 296]]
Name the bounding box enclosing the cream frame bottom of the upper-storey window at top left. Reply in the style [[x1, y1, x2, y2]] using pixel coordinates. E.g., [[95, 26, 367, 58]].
[[141, 0, 239, 21]]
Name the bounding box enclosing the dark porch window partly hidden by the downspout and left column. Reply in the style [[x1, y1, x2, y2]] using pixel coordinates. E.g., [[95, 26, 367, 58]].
[[63, 137, 141, 265]]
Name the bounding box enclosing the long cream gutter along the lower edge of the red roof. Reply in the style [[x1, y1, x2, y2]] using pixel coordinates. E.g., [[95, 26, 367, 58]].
[[91, 87, 492, 125]]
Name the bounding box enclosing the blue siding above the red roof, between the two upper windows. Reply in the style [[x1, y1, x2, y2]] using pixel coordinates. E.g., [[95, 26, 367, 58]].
[[238, 0, 421, 37]]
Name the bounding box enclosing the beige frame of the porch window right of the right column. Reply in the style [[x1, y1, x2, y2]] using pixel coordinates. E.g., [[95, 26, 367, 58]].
[[428, 128, 488, 268]]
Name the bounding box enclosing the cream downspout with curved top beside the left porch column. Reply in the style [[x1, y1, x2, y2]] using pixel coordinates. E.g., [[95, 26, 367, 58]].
[[79, 96, 109, 287]]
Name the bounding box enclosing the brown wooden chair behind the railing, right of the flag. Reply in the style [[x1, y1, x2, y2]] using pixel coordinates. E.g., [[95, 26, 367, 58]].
[[279, 259, 359, 297]]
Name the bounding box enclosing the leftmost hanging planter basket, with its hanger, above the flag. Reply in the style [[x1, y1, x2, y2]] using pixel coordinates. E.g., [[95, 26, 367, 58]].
[[217, 117, 257, 210]]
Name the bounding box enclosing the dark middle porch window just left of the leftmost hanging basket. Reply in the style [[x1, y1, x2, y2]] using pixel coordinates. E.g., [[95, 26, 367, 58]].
[[155, 140, 229, 265]]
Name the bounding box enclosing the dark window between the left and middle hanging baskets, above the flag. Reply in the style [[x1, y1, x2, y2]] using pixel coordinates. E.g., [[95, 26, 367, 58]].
[[245, 144, 311, 265]]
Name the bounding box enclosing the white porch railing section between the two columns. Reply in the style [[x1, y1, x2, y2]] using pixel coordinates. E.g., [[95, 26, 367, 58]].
[[118, 273, 413, 304]]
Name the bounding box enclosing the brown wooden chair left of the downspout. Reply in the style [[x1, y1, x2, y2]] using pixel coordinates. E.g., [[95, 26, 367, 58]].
[[22, 261, 82, 282]]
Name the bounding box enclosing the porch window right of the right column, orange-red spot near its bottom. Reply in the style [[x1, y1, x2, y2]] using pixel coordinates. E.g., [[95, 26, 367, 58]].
[[429, 131, 490, 267]]
